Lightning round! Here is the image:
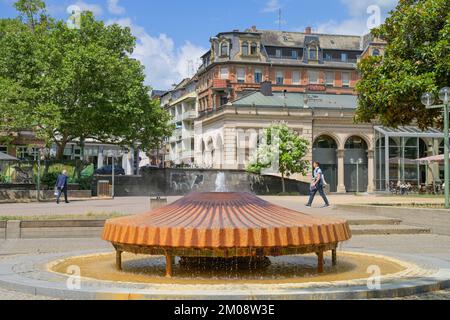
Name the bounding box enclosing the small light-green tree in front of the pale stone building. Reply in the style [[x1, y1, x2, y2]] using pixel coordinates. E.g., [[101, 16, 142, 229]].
[[247, 122, 309, 193]]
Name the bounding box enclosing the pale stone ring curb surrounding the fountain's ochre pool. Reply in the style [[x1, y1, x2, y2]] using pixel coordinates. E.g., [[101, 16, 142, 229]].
[[0, 251, 450, 300]]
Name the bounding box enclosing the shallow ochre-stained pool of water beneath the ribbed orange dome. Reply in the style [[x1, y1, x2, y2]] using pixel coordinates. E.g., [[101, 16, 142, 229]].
[[49, 253, 407, 285]]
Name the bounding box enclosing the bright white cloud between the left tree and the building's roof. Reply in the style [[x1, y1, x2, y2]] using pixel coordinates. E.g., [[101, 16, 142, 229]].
[[107, 18, 207, 89]]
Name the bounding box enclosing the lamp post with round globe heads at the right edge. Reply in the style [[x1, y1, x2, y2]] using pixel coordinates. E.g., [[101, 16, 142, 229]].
[[422, 87, 450, 209]]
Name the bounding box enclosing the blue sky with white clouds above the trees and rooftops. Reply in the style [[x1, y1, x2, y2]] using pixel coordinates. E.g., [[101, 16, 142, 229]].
[[0, 0, 397, 89]]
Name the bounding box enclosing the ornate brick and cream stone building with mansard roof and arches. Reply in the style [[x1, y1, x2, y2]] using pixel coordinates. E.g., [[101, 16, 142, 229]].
[[168, 27, 444, 193]]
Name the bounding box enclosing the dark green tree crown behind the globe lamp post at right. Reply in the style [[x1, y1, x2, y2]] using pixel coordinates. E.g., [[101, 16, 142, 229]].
[[355, 0, 450, 129]]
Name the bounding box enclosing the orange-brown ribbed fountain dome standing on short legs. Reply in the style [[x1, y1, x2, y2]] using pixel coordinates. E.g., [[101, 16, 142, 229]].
[[103, 193, 351, 277]]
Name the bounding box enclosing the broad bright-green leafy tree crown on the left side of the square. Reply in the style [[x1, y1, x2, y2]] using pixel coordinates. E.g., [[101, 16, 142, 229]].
[[0, 0, 173, 159]]
